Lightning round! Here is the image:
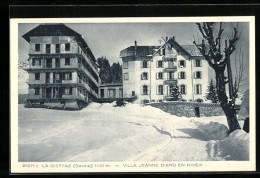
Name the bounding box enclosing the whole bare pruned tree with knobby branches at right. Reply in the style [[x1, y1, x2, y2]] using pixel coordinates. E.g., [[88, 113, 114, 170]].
[[193, 22, 243, 133]]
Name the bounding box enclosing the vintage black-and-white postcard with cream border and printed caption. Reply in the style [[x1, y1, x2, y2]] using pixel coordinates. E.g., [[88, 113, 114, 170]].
[[10, 16, 256, 173]]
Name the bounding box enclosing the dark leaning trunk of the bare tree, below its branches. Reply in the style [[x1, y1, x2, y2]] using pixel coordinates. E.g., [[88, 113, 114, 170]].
[[215, 67, 241, 133]]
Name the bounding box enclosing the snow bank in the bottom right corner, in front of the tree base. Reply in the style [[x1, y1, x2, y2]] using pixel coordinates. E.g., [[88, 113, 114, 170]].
[[207, 130, 249, 161]]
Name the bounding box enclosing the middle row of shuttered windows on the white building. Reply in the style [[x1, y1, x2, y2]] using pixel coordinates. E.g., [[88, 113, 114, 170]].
[[124, 71, 202, 80]]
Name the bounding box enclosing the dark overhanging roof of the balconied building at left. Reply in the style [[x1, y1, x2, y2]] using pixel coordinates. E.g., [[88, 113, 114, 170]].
[[22, 23, 96, 62]]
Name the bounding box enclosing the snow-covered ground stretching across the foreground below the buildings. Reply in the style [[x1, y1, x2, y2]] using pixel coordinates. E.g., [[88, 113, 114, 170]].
[[18, 103, 249, 162]]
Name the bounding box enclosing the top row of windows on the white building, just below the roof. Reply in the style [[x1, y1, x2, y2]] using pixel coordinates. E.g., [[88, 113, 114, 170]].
[[123, 59, 202, 69]]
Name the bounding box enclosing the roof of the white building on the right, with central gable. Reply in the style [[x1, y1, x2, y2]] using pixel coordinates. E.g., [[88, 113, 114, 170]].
[[120, 39, 207, 57]]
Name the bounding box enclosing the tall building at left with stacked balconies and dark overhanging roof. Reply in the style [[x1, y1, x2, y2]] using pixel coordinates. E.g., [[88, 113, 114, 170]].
[[23, 24, 99, 108]]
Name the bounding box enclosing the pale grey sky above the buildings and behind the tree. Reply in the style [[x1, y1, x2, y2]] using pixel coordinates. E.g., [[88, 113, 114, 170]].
[[18, 23, 249, 92]]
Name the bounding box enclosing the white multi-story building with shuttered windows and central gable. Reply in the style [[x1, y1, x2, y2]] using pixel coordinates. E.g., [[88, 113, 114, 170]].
[[120, 37, 214, 102]]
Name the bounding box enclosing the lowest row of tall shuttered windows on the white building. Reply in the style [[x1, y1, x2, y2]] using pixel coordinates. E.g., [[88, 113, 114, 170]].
[[141, 84, 202, 95]]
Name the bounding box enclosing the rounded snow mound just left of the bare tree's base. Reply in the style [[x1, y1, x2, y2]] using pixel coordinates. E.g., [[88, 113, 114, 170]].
[[193, 121, 229, 140]]
